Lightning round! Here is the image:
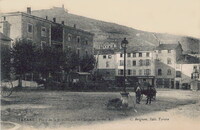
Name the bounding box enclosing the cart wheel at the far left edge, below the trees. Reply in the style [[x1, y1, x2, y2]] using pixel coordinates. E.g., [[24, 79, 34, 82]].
[[1, 80, 13, 97]]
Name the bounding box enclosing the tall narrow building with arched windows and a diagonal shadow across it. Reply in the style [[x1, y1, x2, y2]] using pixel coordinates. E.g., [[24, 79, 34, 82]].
[[154, 44, 183, 88]]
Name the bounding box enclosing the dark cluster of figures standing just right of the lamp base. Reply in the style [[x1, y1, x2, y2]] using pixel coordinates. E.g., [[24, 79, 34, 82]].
[[135, 81, 154, 104]]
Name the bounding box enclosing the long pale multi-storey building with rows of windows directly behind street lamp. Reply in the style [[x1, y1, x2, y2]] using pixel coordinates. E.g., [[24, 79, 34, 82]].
[[116, 47, 155, 85]]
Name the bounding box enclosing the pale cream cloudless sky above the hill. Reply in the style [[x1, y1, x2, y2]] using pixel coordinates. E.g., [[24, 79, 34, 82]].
[[0, 0, 200, 38]]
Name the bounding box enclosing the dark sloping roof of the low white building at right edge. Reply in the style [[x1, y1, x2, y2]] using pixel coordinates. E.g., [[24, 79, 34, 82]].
[[177, 54, 200, 64]]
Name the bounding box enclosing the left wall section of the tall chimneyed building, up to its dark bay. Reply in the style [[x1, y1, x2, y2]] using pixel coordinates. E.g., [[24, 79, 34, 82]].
[[2, 12, 51, 46]]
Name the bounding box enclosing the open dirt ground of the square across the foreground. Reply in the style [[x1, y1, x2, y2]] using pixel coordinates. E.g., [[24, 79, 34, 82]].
[[1, 90, 200, 130]]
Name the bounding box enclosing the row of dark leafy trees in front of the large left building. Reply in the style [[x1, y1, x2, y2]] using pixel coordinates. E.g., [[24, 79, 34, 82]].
[[1, 39, 95, 85]]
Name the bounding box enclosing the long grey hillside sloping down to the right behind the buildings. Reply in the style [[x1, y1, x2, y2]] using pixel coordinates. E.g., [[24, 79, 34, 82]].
[[2, 7, 200, 53]]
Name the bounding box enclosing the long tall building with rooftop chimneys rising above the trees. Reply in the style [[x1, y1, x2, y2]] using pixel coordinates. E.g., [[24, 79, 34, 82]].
[[0, 7, 94, 57]]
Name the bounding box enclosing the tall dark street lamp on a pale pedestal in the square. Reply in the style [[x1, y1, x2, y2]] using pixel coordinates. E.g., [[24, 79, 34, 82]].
[[121, 38, 129, 107]]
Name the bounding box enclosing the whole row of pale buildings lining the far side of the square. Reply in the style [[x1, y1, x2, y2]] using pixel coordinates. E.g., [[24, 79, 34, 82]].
[[95, 43, 200, 89]]
